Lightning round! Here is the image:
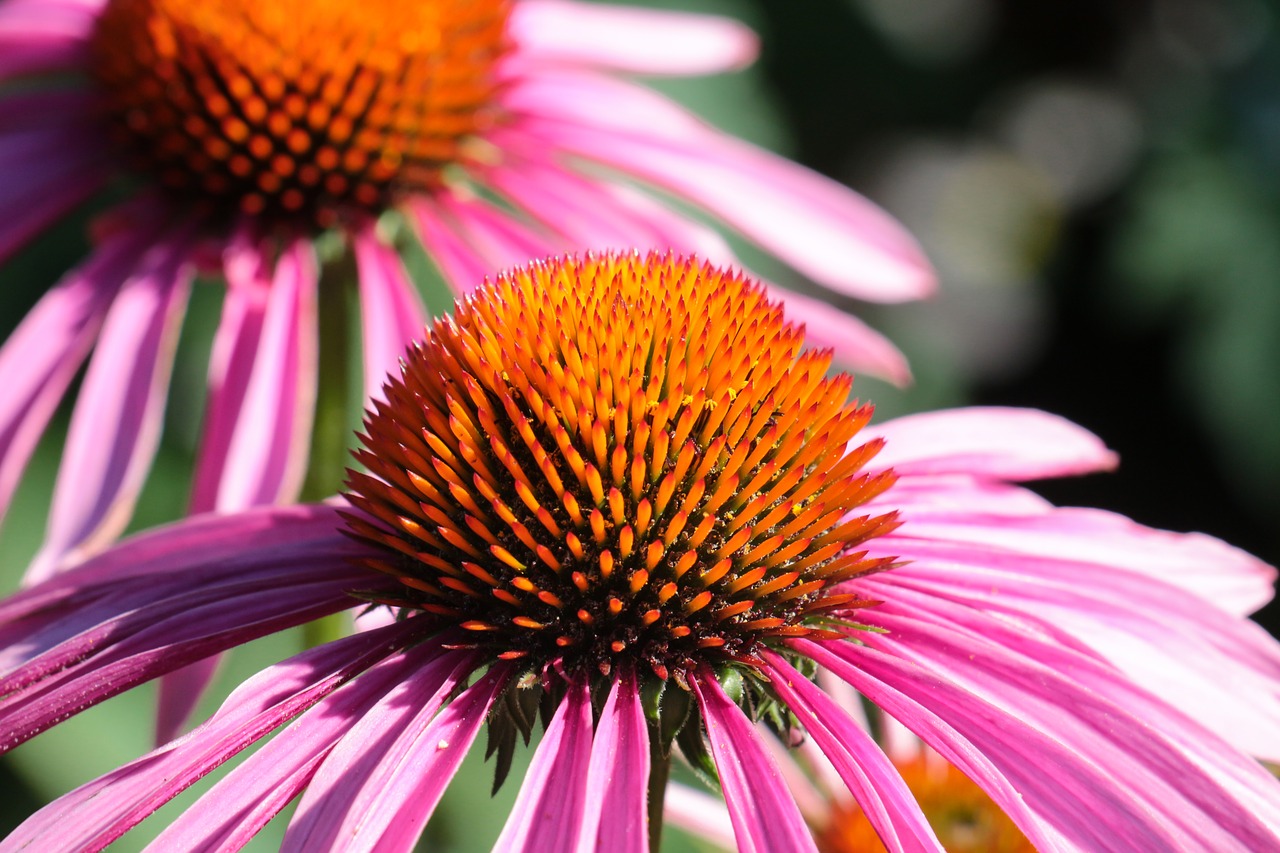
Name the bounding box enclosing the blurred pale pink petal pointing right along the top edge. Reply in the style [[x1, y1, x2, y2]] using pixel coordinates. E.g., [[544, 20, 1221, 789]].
[[507, 0, 758, 76]]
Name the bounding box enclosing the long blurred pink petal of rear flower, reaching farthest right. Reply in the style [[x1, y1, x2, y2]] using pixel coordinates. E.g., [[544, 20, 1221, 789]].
[[490, 73, 933, 301]]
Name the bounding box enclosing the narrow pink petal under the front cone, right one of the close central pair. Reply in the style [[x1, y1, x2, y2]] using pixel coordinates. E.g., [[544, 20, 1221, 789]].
[[573, 672, 649, 853]]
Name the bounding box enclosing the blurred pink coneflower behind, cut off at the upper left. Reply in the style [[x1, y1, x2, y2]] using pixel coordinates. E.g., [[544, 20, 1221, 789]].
[[0, 0, 932, 580]]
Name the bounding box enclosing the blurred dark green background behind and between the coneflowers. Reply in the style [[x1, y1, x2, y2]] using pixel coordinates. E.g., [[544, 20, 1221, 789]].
[[0, 0, 1280, 850]]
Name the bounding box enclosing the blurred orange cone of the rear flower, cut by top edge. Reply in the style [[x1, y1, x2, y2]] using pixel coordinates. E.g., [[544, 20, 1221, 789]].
[[92, 0, 508, 224]]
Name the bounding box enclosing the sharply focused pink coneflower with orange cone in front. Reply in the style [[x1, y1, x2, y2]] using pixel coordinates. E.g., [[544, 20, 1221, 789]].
[[0, 255, 1280, 852]]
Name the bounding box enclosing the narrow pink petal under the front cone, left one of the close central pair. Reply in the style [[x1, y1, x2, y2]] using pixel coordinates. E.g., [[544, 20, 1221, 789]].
[[493, 679, 596, 853]]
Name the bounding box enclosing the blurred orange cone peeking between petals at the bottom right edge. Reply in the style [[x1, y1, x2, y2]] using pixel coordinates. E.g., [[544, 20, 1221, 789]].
[[818, 757, 1036, 853]]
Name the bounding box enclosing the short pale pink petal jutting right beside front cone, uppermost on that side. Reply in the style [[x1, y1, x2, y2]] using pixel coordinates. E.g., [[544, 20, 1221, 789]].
[[858, 409, 1117, 480]]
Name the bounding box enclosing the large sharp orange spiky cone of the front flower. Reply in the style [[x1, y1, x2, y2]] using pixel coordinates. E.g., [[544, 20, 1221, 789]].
[[348, 249, 896, 679]]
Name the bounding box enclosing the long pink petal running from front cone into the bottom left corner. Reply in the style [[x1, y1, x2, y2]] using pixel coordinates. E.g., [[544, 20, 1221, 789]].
[[5, 625, 430, 849]]
